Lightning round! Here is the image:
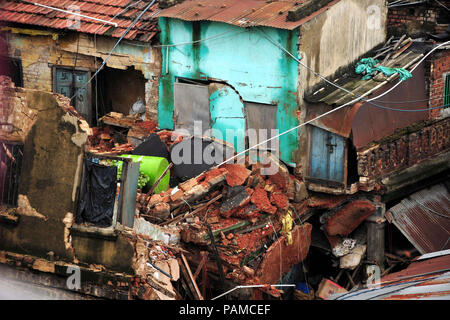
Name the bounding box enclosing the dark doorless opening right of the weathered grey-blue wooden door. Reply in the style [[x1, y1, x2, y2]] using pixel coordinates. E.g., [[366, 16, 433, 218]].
[[92, 67, 146, 123]]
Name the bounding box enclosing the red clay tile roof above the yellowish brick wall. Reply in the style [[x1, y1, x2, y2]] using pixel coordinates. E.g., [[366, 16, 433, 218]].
[[0, 0, 160, 42]]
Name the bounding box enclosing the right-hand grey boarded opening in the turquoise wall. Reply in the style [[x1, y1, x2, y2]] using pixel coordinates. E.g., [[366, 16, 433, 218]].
[[245, 102, 279, 150]]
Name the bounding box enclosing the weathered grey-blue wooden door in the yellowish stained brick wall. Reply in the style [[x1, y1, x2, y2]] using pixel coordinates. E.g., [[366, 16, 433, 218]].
[[55, 68, 92, 124]]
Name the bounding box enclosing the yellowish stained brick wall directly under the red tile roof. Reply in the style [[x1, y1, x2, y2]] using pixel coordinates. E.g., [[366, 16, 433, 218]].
[[3, 28, 161, 119]]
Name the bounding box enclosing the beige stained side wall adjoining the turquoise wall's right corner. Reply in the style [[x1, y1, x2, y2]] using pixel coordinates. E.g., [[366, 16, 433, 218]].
[[296, 0, 387, 174]]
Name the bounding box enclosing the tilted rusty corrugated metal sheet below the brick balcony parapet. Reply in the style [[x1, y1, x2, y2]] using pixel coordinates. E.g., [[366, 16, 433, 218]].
[[386, 183, 450, 254]]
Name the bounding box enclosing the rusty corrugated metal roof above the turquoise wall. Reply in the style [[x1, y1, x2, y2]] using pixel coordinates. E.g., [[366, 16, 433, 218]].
[[158, 0, 340, 30]]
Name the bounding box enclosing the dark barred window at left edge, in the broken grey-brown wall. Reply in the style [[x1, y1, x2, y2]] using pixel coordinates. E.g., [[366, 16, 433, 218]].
[[0, 141, 23, 207]]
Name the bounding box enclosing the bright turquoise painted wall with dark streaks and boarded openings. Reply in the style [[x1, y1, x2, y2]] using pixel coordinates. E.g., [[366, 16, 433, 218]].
[[158, 18, 298, 164]]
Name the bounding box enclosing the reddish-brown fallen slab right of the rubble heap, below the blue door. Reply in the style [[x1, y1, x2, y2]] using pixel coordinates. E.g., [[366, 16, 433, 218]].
[[325, 200, 375, 236]]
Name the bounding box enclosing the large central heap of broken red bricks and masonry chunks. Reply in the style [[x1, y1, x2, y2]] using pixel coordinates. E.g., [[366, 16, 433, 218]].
[[137, 153, 312, 295]]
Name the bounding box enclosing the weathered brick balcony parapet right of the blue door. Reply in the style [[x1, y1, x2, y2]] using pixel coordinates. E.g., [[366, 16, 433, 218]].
[[358, 118, 450, 180]]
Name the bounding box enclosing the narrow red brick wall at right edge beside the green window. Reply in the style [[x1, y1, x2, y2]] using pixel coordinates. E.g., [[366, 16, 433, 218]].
[[429, 50, 450, 118]]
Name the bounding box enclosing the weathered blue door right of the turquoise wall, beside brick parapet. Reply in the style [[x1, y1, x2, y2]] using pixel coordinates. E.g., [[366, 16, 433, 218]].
[[310, 126, 345, 183]]
